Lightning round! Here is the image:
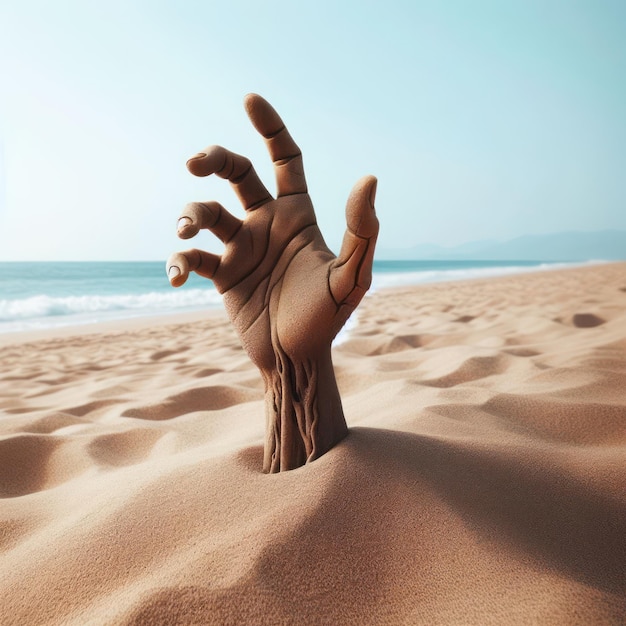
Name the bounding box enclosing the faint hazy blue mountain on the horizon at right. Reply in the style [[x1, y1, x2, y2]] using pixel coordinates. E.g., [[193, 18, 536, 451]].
[[376, 230, 626, 261]]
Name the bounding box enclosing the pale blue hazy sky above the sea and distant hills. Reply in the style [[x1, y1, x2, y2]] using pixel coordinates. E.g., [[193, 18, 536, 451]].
[[0, 0, 626, 261]]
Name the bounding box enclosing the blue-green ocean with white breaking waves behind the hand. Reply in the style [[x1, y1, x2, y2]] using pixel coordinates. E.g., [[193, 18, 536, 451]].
[[0, 261, 596, 333]]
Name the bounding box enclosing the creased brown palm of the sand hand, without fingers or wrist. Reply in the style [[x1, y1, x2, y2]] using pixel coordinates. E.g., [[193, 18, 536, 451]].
[[219, 194, 336, 370]]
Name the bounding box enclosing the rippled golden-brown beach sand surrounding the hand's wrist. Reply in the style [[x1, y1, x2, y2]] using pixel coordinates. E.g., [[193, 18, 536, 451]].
[[0, 263, 626, 626]]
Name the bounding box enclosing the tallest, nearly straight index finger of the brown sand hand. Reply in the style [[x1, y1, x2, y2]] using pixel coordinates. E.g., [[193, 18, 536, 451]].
[[244, 93, 307, 197]]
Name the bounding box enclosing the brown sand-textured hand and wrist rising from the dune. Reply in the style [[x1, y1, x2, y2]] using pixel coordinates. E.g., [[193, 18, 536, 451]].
[[167, 94, 378, 472]]
